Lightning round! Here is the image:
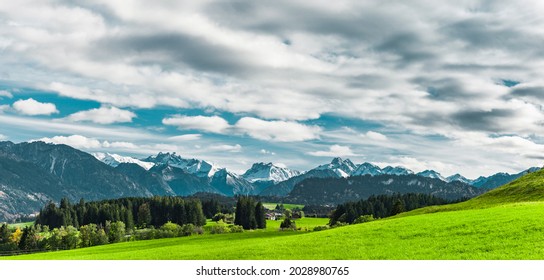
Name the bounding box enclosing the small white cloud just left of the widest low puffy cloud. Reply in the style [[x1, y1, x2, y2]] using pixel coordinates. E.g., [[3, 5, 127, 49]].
[[162, 115, 230, 133]]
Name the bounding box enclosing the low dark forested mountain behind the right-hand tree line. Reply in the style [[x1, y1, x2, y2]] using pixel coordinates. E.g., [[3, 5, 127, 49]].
[[285, 174, 487, 205]]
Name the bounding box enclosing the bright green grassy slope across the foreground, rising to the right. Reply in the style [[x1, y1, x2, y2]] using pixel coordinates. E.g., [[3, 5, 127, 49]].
[[4, 168, 544, 259]]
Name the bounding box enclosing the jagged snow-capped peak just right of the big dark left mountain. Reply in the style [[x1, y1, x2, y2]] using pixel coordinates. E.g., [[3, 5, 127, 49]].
[[142, 152, 220, 177]]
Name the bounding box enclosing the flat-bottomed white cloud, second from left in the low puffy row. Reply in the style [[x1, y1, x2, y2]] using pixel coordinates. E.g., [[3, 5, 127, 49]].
[[66, 106, 136, 124]]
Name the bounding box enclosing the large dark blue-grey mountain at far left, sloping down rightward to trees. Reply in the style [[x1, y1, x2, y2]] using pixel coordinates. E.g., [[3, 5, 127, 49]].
[[0, 142, 153, 221]]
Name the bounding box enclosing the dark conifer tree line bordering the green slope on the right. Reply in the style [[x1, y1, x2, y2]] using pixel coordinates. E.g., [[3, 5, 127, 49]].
[[329, 193, 452, 226]]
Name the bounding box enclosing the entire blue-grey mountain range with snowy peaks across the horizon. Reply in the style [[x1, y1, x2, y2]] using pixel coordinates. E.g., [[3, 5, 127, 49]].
[[0, 142, 538, 220]]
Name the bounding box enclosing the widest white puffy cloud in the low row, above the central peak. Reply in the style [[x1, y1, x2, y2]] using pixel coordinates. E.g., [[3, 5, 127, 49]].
[[234, 117, 322, 142]]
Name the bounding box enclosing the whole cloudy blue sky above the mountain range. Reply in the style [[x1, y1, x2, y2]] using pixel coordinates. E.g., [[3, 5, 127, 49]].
[[0, 0, 544, 178]]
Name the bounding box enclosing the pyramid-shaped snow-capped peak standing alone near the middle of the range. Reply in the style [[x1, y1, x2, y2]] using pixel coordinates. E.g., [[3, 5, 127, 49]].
[[242, 162, 300, 183]]
